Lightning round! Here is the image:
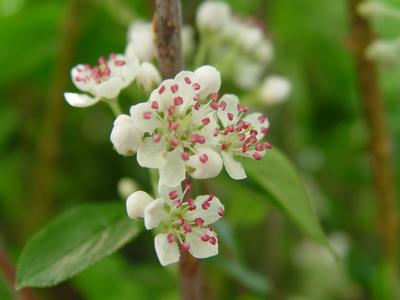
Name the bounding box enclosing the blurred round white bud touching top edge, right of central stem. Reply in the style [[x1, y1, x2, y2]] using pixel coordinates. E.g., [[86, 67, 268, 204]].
[[196, 1, 231, 32]]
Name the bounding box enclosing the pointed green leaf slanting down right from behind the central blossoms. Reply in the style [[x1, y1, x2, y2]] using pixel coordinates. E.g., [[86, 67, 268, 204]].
[[244, 148, 334, 253]]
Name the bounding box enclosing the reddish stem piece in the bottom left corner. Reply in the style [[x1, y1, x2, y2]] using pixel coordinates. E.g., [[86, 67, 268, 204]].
[[0, 241, 37, 300]]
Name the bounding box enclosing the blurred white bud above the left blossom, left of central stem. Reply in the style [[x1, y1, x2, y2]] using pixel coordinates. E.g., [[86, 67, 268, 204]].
[[128, 20, 156, 62]]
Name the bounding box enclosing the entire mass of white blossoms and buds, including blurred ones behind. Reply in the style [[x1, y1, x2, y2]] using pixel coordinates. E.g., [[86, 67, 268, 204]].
[[65, 2, 276, 266]]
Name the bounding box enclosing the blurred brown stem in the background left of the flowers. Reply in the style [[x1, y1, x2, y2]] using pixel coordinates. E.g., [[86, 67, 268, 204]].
[[28, 0, 84, 228]]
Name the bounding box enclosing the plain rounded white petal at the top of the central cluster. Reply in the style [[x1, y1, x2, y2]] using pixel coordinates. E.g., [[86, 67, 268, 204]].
[[194, 65, 221, 99]]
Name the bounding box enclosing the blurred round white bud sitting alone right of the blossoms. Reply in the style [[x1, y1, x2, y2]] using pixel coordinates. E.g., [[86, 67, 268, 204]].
[[260, 76, 292, 105]]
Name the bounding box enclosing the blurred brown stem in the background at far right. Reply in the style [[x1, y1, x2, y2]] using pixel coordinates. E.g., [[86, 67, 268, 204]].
[[349, 0, 397, 266]]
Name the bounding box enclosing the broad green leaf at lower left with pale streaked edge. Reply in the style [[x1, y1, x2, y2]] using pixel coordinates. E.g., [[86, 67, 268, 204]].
[[16, 203, 140, 289]]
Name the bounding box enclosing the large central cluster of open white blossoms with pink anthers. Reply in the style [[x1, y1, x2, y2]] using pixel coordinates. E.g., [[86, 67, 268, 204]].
[[111, 66, 269, 187]]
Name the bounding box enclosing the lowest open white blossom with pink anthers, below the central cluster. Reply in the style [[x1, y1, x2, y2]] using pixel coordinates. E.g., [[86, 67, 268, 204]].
[[127, 182, 224, 266]]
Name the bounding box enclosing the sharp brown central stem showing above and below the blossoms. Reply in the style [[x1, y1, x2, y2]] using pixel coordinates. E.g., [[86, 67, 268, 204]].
[[153, 0, 203, 300]]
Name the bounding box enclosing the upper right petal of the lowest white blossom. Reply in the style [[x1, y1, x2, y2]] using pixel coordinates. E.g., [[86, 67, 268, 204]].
[[188, 195, 225, 226]]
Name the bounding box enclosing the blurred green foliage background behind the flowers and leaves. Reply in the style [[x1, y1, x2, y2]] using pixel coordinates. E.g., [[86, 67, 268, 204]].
[[0, 0, 400, 300]]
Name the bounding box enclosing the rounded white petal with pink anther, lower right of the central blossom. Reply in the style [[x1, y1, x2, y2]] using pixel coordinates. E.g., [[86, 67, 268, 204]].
[[187, 147, 222, 179]]
